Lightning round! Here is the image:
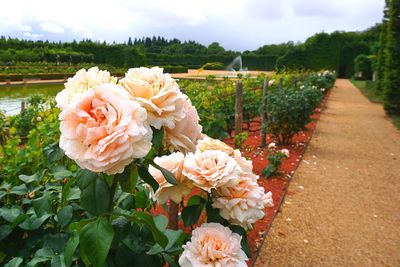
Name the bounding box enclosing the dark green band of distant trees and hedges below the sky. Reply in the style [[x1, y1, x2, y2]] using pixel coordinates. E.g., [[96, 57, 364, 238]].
[[0, 25, 381, 77]]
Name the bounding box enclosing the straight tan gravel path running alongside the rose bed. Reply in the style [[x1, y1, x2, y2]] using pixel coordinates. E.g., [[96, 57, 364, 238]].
[[255, 79, 400, 266]]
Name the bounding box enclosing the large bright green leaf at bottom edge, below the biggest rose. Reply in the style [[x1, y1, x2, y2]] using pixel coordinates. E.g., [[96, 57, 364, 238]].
[[79, 218, 114, 267]]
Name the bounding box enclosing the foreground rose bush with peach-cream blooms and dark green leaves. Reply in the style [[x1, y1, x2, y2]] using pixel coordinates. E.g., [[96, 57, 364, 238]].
[[0, 68, 271, 266]]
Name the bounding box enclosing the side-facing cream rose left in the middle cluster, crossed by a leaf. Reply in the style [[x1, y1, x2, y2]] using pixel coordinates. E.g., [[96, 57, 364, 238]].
[[149, 152, 192, 204]]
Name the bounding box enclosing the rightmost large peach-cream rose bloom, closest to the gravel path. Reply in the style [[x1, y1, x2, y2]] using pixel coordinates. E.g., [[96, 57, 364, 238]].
[[212, 175, 273, 230]]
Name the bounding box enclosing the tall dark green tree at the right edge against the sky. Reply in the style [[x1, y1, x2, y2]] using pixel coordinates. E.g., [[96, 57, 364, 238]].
[[383, 0, 400, 114]]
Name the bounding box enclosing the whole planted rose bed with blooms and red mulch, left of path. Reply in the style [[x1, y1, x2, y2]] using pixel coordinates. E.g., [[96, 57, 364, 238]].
[[0, 67, 335, 266]]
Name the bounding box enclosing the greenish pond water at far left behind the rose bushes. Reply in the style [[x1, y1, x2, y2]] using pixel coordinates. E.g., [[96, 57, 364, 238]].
[[0, 83, 64, 115]]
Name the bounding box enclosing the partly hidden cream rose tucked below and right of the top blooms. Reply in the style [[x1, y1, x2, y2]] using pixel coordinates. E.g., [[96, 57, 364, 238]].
[[164, 100, 202, 153]]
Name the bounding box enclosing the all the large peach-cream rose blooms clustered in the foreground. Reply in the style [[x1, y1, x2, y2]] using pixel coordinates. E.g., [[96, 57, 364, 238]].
[[56, 67, 272, 266]]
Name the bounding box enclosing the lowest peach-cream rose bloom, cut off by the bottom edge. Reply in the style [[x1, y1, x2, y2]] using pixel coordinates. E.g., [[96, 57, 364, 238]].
[[179, 223, 247, 267]]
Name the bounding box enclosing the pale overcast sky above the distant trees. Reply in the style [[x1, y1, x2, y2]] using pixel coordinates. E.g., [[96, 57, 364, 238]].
[[0, 0, 384, 51]]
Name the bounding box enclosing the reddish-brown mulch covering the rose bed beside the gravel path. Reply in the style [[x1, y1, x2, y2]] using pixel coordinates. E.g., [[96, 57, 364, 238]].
[[153, 92, 329, 266]]
